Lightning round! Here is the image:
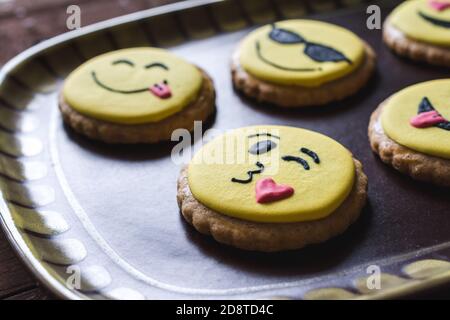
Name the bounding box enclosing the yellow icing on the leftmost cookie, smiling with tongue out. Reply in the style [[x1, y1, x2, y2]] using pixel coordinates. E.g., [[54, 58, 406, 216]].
[[63, 48, 202, 124]]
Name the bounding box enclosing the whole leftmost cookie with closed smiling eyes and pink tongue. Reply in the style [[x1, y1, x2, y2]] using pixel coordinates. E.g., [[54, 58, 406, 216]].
[[59, 48, 215, 143]]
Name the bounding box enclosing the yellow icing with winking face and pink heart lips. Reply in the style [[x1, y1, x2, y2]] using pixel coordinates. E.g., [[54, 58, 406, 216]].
[[188, 126, 355, 223]]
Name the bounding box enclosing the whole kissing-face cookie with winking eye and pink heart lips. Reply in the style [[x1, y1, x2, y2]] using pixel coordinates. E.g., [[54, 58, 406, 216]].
[[178, 126, 367, 252]]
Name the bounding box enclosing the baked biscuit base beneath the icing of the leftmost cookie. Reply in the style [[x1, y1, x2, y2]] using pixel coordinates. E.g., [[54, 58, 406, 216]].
[[59, 70, 216, 144]]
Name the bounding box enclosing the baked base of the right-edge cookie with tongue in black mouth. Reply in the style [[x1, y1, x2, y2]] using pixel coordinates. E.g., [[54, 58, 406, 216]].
[[368, 101, 450, 187]]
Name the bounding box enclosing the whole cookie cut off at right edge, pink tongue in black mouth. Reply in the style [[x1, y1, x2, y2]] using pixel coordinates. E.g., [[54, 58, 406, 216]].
[[369, 79, 450, 186]]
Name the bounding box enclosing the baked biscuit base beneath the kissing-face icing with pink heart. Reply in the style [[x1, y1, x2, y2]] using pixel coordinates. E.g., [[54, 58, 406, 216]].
[[177, 159, 367, 252]]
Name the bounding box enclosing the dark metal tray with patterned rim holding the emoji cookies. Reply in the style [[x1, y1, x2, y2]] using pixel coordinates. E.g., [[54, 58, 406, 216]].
[[0, 0, 450, 299]]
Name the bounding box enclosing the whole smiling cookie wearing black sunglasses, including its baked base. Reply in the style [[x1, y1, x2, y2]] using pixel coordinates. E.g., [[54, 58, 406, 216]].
[[232, 20, 375, 107]]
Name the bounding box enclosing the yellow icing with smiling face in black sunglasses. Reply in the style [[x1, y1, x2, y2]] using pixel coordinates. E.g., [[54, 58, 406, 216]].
[[240, 20, 365, 87]]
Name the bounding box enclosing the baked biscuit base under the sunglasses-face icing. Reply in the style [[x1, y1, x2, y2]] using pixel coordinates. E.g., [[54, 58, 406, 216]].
[[231, 44, 376, 108]]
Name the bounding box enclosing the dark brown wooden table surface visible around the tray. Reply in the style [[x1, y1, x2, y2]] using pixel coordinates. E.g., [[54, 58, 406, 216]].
[[0, 0, 450, 300]]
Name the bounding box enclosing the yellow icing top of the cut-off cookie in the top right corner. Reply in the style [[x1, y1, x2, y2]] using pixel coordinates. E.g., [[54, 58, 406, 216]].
[[389, 0, 450, 47]]
